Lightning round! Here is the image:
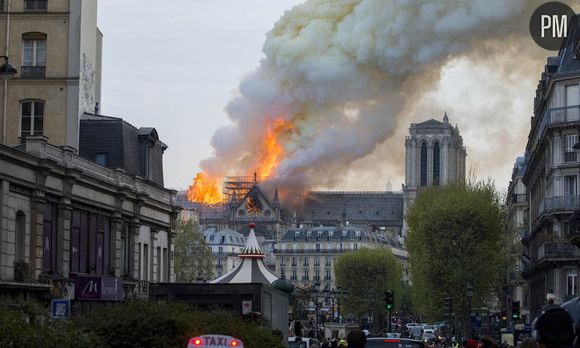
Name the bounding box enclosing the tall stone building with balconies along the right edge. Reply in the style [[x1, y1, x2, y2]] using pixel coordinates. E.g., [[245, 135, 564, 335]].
[[522, 17, 580, 318]]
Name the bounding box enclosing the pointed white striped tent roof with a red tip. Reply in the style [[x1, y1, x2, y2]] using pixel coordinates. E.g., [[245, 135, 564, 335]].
[[211, 222, 279, 285]]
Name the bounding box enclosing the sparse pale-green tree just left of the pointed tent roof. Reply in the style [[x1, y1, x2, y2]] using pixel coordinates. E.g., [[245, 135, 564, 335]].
[[174, 220, 213, 283]]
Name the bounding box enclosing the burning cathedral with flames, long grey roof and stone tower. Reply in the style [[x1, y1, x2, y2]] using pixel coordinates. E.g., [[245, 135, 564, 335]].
[[178, 114, 466, 240]]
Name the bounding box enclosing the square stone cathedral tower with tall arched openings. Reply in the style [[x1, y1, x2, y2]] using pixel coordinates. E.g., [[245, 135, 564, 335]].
[[403, 113, 467, 236]]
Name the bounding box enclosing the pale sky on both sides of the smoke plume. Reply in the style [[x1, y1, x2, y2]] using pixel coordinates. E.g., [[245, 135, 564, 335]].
[[98, 0, 578, 190]]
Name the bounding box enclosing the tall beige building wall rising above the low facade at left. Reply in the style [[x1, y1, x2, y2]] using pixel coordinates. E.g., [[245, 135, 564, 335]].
[[0, 0, 102, 149]]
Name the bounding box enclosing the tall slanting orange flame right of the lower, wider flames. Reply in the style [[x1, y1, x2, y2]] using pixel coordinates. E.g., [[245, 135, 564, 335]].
[[255, 118, 294, 176]]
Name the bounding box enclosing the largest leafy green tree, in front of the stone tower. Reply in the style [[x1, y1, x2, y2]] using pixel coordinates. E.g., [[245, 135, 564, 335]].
[[407, 182, 506, 319]]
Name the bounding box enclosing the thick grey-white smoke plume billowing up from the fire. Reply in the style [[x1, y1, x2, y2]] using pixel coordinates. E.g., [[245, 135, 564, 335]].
[[201, 0, 537, 198]]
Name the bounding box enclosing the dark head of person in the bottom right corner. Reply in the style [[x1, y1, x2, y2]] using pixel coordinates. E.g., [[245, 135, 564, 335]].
[[532, 307, 574, 348]]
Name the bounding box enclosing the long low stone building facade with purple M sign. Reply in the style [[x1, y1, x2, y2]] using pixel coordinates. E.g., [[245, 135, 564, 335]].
[[0, 136, 177, 298]]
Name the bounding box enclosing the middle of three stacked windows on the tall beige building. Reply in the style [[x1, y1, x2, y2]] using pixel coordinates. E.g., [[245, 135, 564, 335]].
[[20, 33, 46, 78]]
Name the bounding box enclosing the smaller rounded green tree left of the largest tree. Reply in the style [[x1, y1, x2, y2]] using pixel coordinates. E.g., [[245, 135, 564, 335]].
[[334, 248, 403, 331]]
